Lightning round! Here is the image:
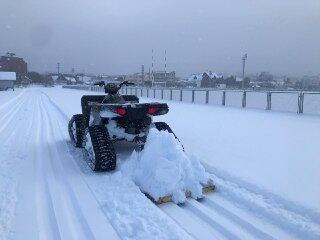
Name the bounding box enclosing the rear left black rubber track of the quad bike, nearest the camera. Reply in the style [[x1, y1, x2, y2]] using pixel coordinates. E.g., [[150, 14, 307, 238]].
[[83, 125, 117, 172]]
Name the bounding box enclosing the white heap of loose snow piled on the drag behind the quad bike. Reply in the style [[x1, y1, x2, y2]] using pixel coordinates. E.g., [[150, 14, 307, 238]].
[[121, 128, 209, 203]]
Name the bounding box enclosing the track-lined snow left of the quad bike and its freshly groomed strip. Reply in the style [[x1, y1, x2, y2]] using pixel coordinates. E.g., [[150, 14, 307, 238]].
[[0, 88, 191, 239]]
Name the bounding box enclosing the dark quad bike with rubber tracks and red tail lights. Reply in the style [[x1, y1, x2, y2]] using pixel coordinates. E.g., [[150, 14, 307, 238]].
[[68, 81, 176, 171]]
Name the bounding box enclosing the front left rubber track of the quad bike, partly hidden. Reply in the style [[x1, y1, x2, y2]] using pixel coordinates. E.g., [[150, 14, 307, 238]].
[[68, 114, 84, 148]]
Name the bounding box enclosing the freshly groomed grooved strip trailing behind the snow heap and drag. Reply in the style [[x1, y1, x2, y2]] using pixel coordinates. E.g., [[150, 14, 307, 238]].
[[160, 172, 320, 240]]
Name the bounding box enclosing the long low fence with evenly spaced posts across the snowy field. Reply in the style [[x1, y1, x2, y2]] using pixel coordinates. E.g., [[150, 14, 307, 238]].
[[64, 85, 320, 114]]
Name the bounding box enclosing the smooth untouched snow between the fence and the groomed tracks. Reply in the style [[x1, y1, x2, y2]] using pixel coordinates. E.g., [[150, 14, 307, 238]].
[[46, 86, 320, 214]]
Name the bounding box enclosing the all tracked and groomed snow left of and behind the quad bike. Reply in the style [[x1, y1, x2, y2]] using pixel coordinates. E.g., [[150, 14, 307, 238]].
[[0, 89, 320, 240]]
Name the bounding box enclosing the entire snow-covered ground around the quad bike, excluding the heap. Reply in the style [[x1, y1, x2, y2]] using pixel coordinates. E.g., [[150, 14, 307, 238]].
[[0, 88, 320, 239]]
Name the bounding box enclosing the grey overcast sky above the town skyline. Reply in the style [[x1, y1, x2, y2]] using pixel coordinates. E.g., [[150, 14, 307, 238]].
[[0, 0, 320, 76]]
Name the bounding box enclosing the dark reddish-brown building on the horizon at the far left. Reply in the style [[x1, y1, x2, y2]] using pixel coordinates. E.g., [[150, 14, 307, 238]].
[[0, 53, 29, 83]]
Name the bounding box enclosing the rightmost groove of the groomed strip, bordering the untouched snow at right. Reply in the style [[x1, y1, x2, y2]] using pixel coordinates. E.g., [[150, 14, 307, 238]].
[[208, 172, 320, 239]]
